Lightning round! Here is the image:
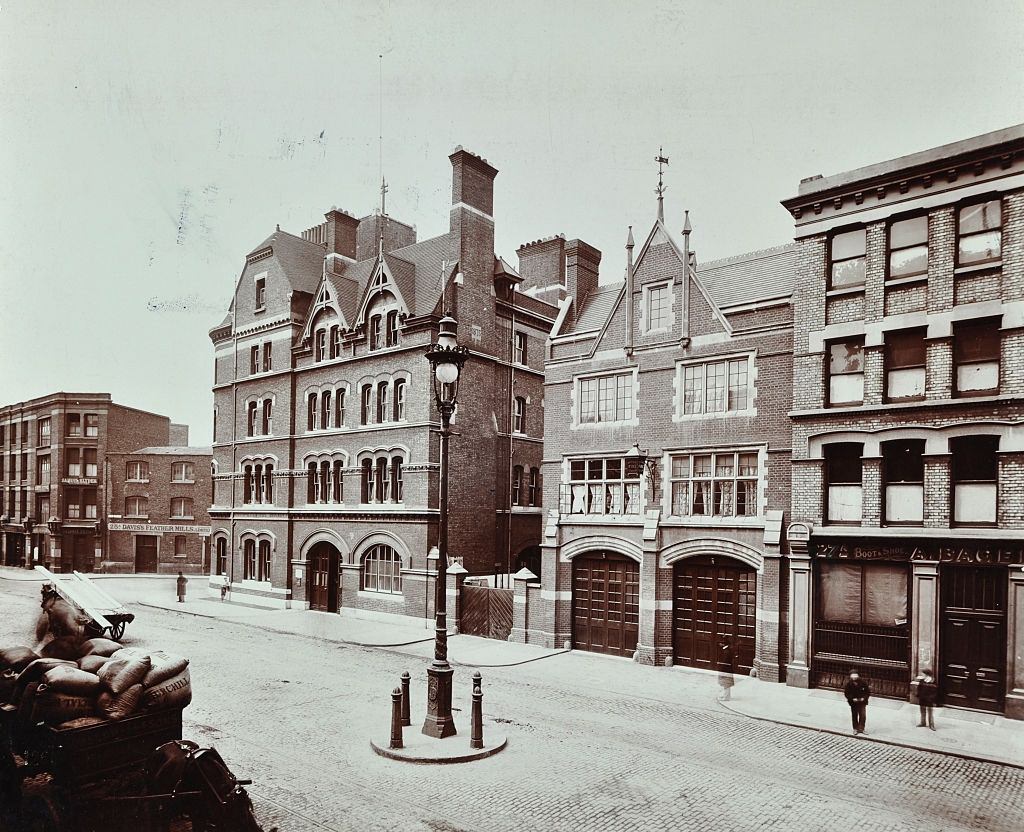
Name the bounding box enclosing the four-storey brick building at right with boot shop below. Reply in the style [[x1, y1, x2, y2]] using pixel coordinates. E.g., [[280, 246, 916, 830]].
[[783, 125, 1024, 718]]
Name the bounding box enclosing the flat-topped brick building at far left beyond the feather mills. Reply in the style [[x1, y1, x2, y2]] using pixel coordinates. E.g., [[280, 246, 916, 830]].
[[0, 392, 188, 572]]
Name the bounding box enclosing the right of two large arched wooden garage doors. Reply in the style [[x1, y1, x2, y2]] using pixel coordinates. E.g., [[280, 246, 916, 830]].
[[672, 555, 757, 673]]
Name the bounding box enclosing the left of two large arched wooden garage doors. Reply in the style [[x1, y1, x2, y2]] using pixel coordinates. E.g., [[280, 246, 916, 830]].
[[572, 552, 640, 656]]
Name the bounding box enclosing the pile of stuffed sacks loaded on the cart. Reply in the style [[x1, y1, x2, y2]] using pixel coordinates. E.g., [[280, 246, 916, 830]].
[[0, 638, 191, 727]]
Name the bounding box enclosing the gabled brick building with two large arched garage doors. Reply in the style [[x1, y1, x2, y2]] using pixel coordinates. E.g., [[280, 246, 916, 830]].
[[512, 202, 796, 680]]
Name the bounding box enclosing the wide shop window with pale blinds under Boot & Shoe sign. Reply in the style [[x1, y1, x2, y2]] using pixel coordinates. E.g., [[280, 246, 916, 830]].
[[817, 560, 907, 627]]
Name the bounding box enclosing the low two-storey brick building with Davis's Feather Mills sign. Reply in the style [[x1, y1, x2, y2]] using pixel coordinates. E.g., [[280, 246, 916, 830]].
[[103, 446, 212, 574]]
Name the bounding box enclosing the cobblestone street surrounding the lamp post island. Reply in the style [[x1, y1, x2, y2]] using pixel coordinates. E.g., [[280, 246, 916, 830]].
[[0, 581, 1024, 832]]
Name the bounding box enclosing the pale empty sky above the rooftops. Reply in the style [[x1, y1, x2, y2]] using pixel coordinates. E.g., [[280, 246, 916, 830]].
[[0, 0, 1024, 445]]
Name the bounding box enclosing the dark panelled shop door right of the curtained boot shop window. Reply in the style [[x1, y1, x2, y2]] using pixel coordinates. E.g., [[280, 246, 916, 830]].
[[939, 566, 1007, 711]]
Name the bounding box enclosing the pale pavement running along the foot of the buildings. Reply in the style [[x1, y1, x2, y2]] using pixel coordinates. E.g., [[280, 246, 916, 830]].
[[9, 568, 1024, 768]]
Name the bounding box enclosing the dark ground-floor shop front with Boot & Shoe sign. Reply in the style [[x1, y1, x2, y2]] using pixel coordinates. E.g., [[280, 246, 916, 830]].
[[791, 535, 1024, 718]]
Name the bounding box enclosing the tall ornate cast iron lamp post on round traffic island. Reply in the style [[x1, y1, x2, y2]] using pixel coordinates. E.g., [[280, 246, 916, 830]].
[[423, 315, 469, 740]]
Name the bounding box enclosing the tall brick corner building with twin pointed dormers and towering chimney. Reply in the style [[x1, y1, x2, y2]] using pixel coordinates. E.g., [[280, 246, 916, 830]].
[[210, 148, 557, 617]]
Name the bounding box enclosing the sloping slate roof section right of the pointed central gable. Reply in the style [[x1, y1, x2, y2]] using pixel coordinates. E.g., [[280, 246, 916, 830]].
[[697, 243, 797, 308]]
